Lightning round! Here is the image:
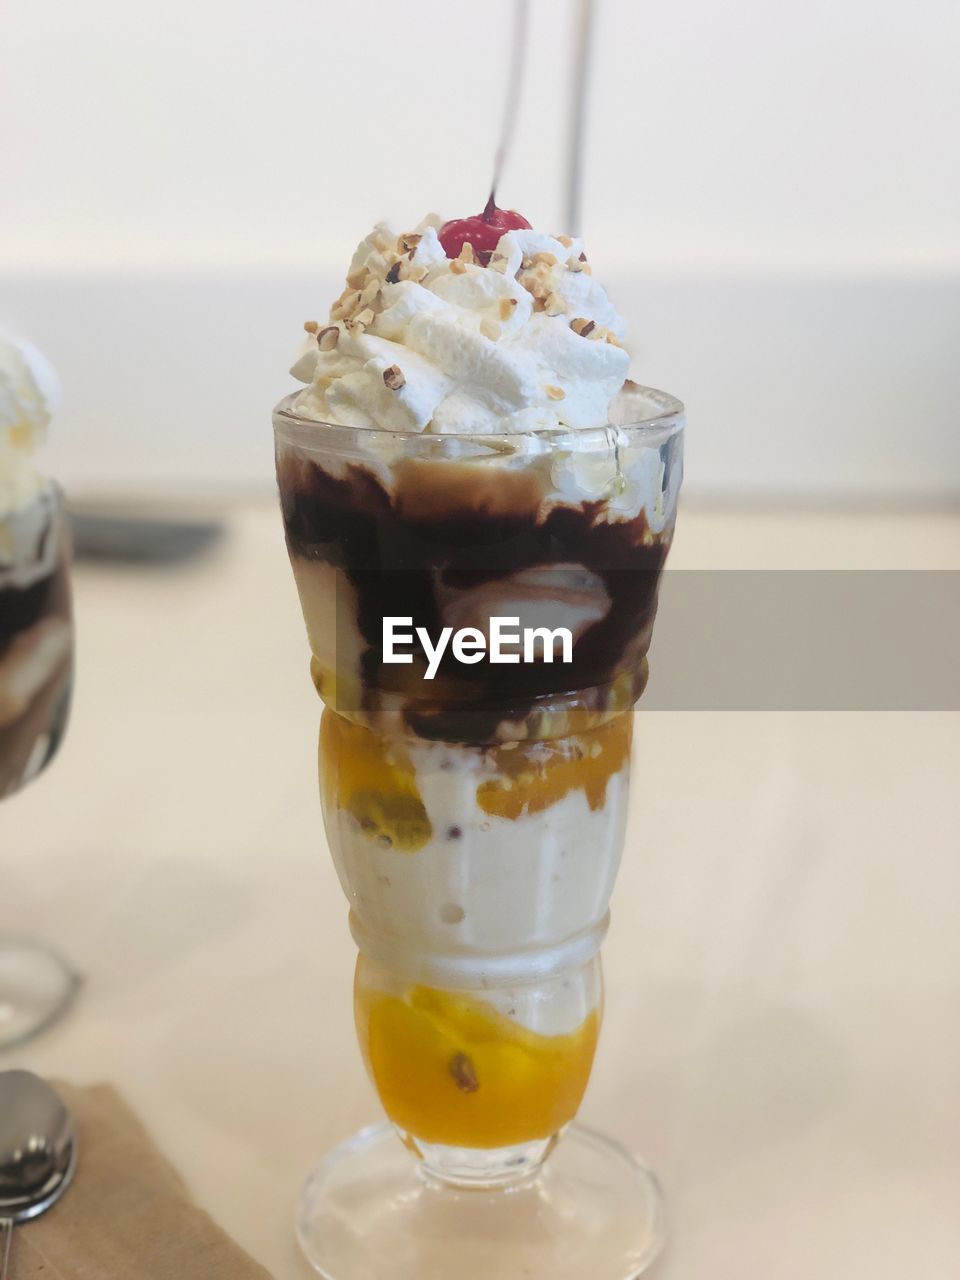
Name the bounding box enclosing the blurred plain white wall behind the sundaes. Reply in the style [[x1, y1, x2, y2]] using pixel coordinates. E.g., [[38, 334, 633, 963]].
[[0, 0, 960, 495]]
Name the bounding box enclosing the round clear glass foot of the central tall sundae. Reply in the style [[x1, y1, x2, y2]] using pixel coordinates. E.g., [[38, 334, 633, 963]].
[[297, 1125, 663, 1280]]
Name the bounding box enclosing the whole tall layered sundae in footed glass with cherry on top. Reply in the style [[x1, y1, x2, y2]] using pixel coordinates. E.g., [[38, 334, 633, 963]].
[[274, 206, 682, 1280]]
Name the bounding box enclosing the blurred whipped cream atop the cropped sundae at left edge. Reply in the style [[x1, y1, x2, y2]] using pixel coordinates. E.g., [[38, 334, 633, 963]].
[[0, 334, 59, 517]]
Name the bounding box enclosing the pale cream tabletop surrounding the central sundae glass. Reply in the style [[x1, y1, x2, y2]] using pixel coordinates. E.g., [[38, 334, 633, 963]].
[[0, 504, 960, 1280]]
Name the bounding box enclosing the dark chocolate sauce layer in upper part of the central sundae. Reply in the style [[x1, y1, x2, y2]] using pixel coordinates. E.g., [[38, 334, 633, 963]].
[[276, 448, 671, 742]]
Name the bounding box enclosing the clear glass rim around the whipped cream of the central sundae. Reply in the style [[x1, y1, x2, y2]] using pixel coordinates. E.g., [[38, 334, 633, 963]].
[[273, 380, 686, 452]]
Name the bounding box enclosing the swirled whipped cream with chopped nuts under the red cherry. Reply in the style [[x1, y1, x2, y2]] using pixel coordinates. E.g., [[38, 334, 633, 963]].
[[291, 216, 630, 435]]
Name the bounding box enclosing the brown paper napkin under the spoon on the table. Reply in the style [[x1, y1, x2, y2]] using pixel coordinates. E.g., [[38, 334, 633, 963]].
[[10, 1082, 270, 1280]]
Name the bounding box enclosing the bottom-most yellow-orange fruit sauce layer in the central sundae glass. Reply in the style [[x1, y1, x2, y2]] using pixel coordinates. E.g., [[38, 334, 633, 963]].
[[355, 984, 600, 1148]]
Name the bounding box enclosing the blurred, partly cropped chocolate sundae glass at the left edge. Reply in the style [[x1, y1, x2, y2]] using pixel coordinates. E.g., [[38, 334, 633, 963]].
[[0, 335, 77, 1048]]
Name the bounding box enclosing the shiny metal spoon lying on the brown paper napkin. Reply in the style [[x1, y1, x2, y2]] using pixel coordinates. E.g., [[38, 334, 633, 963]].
[[0, 1071, 77, 1280]]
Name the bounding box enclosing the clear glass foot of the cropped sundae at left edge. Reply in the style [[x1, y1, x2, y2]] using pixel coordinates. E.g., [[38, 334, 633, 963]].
[[0, 938, 81, 1050]]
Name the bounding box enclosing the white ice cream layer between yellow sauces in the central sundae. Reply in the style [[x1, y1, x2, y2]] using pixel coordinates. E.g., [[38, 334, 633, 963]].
[[325, 740, 630, 986]]
